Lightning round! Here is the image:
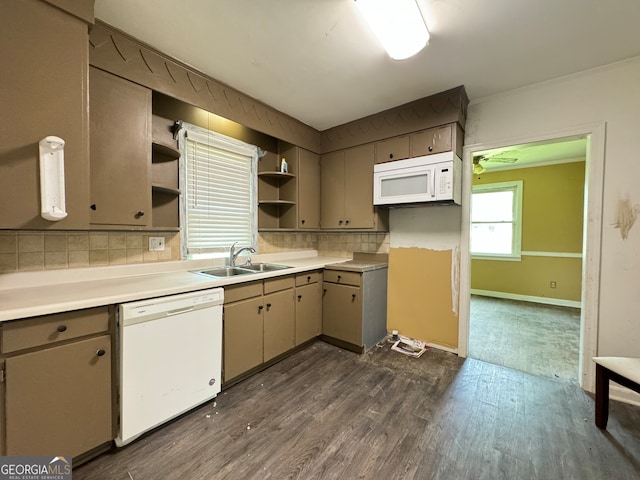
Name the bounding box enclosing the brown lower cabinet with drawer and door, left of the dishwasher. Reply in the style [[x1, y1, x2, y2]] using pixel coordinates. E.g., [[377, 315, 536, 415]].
[[0, 307, 115, 457]]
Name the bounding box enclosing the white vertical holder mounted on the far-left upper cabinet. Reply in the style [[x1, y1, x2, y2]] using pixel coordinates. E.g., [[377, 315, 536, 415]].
[[39, 136, 67, 222]]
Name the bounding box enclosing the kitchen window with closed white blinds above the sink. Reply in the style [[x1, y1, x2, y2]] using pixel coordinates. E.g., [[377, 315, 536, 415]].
[[180, 123, 258, 256]]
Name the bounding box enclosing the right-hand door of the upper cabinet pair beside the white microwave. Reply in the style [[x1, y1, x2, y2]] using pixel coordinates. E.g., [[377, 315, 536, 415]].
[[344, 144, 375, 228]]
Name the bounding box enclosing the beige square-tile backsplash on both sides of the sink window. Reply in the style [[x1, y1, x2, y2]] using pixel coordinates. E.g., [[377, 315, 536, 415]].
[[0, 230, 389, 273]]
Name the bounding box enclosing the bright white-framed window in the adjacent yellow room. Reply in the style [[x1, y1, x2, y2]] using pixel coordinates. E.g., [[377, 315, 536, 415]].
[[471, 180, 522, 260]]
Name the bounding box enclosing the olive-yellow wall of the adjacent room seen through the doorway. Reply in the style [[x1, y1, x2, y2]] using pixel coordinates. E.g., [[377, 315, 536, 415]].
[[471, 161, 584, 301]]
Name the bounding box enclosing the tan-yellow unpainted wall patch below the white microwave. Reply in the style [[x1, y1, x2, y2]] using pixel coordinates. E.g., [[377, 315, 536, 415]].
[[387, 248, 458, 349]]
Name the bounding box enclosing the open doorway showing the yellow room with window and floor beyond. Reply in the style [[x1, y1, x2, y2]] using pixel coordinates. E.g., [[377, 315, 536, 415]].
[[469, 136, 587, 382]]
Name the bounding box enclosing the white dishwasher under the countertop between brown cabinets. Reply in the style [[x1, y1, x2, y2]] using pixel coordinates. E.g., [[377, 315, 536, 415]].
[[116, 288, 224, 447]]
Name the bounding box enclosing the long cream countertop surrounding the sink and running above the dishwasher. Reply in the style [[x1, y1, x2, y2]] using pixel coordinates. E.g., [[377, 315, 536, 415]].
[[0, 250, 345, 321]]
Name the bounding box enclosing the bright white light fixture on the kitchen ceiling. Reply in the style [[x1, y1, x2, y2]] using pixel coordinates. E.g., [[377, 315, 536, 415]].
[[355, 0, 429, 60]]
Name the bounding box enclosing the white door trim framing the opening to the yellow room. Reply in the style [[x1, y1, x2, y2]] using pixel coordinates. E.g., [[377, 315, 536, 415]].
[[458, 122, 606, 392]]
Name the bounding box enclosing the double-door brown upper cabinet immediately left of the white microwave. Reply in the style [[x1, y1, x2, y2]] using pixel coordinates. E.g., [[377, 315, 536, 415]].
[[320, 143, 388, 230]]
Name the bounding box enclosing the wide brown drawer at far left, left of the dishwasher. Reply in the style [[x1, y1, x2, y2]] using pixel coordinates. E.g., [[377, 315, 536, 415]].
[[0, 306, 109, 353]]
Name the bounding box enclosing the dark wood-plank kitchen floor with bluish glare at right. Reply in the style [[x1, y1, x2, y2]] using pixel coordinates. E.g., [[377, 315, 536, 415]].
[[73, 342, 640, 480]]
